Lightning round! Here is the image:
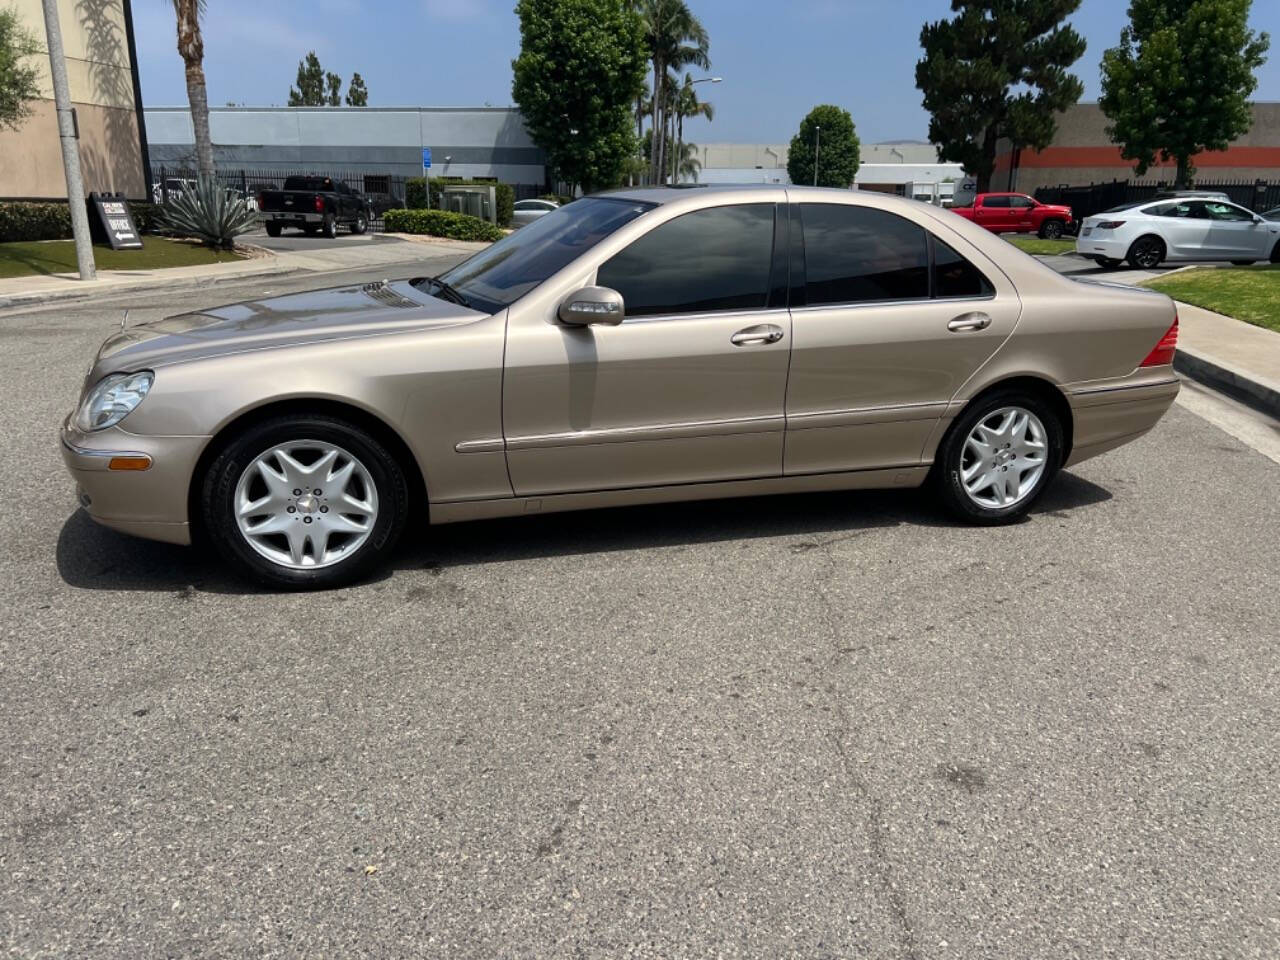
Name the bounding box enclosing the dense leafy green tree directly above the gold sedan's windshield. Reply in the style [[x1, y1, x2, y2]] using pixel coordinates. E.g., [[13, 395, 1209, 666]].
[[511, 0, 645, 193]]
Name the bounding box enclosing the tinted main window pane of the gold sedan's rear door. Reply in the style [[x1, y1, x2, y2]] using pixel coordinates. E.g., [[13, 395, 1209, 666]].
[[800, 204, 929, 306]]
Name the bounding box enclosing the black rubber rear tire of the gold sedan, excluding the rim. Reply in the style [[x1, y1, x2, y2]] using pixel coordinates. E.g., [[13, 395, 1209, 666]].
[[931, 389, 1065, 526]]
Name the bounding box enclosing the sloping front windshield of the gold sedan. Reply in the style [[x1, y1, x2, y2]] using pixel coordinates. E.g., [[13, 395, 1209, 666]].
[[430, 197, 655, 314]]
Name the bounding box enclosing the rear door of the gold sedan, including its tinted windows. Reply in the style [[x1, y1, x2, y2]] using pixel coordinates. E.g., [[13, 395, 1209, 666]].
[[783, 204, 1021, 475]]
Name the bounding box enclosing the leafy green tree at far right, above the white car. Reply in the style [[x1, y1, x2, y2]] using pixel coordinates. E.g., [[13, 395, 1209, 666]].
[[1098, 0, 1271, 187]]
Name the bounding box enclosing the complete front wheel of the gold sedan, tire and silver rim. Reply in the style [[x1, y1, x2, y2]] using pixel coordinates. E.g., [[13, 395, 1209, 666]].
[[202, 416, 408, 589]]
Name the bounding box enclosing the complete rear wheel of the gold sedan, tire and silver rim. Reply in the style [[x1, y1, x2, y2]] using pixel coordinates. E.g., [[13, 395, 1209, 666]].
[[934, 390, 1064, 525]]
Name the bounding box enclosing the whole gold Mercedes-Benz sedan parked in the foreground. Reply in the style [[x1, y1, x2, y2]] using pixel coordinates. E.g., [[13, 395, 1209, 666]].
[[61, 186, 1179, 588]]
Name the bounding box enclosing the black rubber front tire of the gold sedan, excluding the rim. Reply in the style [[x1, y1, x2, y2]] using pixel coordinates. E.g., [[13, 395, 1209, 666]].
[[201, 415, 410, 590]]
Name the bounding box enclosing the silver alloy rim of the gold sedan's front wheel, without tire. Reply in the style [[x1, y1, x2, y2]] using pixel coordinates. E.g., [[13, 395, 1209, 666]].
[[234, 440, 378, 570]]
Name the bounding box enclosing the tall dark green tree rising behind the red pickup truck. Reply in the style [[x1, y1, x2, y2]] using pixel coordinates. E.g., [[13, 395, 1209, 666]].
[[915, 0, 1084, 192]]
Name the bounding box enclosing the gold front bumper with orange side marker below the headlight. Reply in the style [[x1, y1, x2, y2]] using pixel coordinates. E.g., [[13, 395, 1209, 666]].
[[60, 417, 209, 544]]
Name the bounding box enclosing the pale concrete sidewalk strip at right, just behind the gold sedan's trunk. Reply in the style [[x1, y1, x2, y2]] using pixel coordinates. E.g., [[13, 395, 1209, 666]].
[[1174, 301, 1280, 420]]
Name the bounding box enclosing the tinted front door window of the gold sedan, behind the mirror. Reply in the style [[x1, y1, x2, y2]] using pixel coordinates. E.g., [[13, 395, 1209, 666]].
[[595, 204, 773, 316]]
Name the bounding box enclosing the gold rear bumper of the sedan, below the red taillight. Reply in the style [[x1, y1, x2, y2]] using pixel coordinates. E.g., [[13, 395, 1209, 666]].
[[1065, 366, 1181, 466]]
